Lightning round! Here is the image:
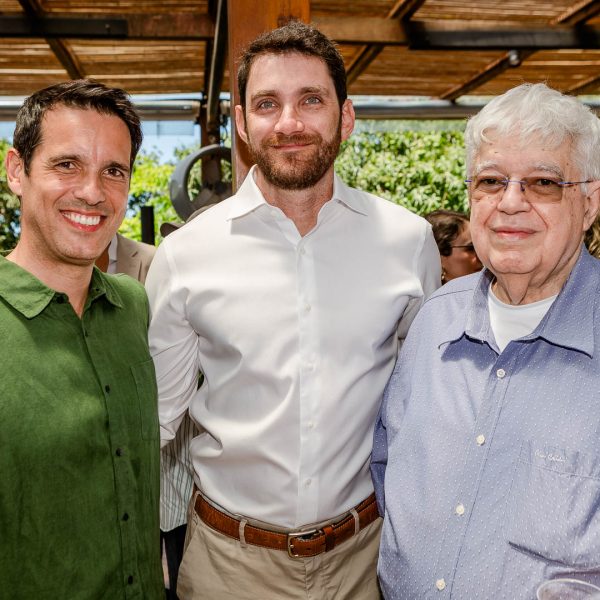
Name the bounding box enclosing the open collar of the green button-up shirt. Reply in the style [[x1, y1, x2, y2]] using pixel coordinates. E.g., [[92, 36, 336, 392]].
[[0, 256, 123, 319]]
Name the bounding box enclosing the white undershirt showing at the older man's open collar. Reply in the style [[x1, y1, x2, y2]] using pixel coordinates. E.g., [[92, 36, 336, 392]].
[[488, 284, 556, 352]]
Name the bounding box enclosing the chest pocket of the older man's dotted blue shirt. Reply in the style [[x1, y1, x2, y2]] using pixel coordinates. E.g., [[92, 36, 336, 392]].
[[505, 442, 600, 570]]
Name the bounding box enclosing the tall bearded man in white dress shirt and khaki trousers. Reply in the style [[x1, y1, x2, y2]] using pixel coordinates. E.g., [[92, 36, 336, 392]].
[[146, 22, 440, 600]]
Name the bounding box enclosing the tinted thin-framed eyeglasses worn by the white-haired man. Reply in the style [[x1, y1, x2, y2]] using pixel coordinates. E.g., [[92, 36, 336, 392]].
[[465, 175, 591, 202]]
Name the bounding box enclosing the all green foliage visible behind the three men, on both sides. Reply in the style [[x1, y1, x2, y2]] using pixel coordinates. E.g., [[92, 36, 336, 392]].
[[0, 125, 467, 250]]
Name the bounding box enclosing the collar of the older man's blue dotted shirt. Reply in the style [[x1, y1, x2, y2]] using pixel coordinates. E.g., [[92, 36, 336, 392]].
[[440, 246, 600, 357]]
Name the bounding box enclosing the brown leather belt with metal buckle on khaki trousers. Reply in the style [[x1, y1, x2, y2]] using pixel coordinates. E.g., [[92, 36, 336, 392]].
[[194, 494, 379, 558]]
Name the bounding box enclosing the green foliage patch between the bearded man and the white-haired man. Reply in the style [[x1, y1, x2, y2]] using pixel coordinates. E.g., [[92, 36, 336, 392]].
[[336, 130, 467, 215]]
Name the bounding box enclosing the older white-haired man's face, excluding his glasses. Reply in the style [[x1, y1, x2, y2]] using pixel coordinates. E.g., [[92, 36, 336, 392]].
[[470, 132, 600, 304]]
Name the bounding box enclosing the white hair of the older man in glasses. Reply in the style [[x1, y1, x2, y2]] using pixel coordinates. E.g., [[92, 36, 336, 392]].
[[465, 83, 600, 180]]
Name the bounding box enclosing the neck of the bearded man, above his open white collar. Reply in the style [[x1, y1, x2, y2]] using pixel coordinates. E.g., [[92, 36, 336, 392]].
[[255, 166, 333, 236]]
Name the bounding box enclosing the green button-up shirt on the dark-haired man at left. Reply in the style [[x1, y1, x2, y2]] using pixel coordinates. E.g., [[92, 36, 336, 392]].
[[0, 256, 164, 600]]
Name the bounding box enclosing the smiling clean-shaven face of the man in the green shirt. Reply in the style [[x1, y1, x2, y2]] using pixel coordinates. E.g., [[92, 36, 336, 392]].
[[6, 105, 131, 267]]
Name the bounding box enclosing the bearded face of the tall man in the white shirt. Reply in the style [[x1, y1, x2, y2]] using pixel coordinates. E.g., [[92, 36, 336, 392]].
[[236, 53, 354, 190]]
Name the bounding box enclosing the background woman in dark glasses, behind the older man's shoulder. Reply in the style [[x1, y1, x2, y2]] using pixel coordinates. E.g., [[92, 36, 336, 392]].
[[425, 210, 482, 283]]
